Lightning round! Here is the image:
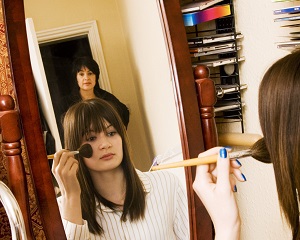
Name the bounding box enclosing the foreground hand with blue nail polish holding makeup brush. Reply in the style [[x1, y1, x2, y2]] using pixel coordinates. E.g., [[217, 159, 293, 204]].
[[193, 147, 246, 240]]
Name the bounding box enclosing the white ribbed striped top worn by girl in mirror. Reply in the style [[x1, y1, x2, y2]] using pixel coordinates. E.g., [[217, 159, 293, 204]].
[[58, 170, 190, 240]]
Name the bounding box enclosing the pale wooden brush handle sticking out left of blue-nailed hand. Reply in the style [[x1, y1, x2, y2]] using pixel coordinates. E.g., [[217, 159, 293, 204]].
[[151, 155, 218, 171]]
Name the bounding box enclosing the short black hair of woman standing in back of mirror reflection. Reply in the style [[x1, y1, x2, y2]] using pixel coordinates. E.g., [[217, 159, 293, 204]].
[[72, 57, 100, 91]]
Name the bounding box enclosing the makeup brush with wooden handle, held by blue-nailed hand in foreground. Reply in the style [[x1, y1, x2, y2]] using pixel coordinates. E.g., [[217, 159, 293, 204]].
[[150, 138, 271, 171]]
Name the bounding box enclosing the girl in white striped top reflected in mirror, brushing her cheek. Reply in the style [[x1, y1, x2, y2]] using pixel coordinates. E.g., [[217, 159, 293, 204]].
[[52, 98, 190, 240]]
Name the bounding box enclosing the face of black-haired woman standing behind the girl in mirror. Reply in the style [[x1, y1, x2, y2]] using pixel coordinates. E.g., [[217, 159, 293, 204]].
[[76, 67, 96, 91]]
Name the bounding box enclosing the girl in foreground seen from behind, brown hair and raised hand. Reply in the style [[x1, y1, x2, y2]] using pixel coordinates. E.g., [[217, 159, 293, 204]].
[[193, 50, 300, 240]]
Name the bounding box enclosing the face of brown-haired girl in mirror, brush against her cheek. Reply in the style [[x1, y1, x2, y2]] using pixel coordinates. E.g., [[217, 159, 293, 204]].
[[82, 122, 123, 173]]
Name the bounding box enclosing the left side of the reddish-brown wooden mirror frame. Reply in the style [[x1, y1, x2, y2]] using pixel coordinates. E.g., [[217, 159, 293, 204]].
[[3, 0, 66, 239]]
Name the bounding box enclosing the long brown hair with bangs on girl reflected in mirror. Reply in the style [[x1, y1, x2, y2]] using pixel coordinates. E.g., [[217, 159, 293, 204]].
[[64, 98, 146, 234]]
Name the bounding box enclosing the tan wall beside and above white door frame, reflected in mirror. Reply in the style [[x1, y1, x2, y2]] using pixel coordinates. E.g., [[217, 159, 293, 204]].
[[24, 0, 155, 170]]
